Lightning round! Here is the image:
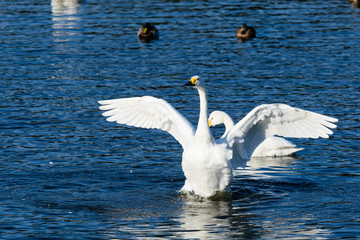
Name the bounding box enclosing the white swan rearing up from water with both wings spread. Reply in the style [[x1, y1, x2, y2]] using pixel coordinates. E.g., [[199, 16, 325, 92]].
[[99, 76, 337, 197]]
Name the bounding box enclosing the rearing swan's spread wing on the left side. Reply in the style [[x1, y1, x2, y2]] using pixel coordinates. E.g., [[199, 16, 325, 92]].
[[99, 96, 194, 148]]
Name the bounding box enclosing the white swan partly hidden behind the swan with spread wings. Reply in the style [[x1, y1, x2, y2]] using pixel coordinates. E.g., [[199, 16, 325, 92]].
[[208, 110, 304, 157]]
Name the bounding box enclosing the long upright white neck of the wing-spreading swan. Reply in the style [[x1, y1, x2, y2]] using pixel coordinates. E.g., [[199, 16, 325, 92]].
[[195, 88, 215, 143]]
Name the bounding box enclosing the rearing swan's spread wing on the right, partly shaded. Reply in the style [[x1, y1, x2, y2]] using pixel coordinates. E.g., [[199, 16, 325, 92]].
[[226, 104, 337, 164]]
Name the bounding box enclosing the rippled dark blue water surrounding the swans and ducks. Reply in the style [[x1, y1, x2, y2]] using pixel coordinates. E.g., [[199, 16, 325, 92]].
[[0, 0, 360, 239]]
